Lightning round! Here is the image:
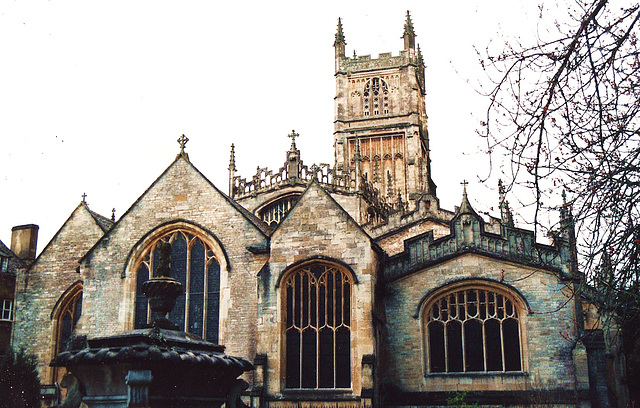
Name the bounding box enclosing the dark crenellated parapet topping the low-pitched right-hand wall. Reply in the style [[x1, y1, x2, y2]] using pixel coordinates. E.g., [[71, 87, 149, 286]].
[[382, 193, 572, 281]]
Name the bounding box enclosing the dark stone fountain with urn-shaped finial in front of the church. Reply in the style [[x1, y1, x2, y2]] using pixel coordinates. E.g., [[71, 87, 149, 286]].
[[51, 246, 254, 408]]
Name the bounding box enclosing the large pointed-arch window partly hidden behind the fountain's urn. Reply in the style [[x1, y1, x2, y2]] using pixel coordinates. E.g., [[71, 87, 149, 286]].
[[135, 230, 220, 343]]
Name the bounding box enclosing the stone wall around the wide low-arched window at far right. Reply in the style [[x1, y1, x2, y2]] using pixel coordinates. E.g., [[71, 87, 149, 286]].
[[381, 254, 576, 391]]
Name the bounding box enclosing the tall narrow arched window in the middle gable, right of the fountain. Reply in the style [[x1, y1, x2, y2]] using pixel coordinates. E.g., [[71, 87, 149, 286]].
[[282, 263, 353, 389]]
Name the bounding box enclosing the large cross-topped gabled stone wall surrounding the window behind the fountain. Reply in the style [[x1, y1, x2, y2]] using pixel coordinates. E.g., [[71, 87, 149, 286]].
[[80, 156, 267, 370]]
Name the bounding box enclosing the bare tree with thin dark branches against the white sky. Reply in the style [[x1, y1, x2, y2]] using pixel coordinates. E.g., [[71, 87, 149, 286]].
[[480, 0, 640, 301]]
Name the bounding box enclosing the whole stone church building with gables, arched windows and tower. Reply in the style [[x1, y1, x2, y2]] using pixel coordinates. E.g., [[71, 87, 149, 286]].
[[7, 14, 624, 408]]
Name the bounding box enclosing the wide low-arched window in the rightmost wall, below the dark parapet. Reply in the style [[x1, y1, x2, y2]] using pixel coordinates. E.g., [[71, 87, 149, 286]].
[[423, 287, 522, 373]]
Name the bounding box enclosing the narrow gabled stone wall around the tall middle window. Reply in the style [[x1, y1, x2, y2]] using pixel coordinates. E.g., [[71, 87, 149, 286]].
[[258, 183, 378, 399]]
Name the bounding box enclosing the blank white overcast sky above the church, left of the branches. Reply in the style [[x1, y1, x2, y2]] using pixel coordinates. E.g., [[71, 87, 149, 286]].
[[0, 0, 552, 252]]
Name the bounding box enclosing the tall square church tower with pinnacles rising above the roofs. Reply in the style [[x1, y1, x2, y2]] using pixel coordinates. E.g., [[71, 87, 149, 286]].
[[334, 11, 436, 204]]
